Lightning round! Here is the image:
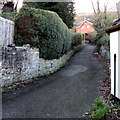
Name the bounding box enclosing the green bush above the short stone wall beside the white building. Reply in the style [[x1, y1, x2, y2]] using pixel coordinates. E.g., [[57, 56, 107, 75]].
[[98, 34, 110, 46]]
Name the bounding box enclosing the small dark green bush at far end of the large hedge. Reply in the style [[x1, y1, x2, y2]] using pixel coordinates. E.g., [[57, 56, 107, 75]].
[[72, 33, 83, 47]]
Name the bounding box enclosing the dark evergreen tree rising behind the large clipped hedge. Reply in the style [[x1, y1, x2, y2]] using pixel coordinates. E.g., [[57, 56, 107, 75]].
[[26, 2, 75, 28]]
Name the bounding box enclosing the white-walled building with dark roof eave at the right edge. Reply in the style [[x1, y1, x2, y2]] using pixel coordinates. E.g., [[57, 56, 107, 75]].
[[106, 19, 120, 101]]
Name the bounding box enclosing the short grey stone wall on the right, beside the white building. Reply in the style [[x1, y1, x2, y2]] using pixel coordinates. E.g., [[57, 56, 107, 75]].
[[100, 46, 110, 60]]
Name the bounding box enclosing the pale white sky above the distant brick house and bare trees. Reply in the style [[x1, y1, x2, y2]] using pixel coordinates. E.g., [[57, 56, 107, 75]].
[[74, 0, 120, 13]]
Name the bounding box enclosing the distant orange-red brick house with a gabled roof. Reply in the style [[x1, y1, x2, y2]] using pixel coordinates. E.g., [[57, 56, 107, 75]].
[[76, 20, 94, 33]]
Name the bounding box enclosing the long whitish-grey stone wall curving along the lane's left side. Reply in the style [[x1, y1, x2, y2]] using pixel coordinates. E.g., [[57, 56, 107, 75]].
[[1, 45, 81, 87]]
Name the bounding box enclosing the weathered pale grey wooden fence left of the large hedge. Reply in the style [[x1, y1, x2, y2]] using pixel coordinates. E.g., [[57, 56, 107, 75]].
[[0, 17, 14, 46]]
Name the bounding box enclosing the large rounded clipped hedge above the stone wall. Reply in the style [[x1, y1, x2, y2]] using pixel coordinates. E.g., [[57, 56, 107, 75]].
[[15, 7, 72, 59]]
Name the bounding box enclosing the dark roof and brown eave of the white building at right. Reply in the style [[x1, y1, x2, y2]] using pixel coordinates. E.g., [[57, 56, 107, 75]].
[[106, 18, 120, 33]]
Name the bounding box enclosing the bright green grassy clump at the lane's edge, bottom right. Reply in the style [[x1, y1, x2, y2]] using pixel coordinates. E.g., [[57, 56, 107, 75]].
[[89, 98, 111, 119]]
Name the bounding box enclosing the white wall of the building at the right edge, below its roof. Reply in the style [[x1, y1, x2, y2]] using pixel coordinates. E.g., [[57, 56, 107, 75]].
[[110, 31, 120, 98]]
